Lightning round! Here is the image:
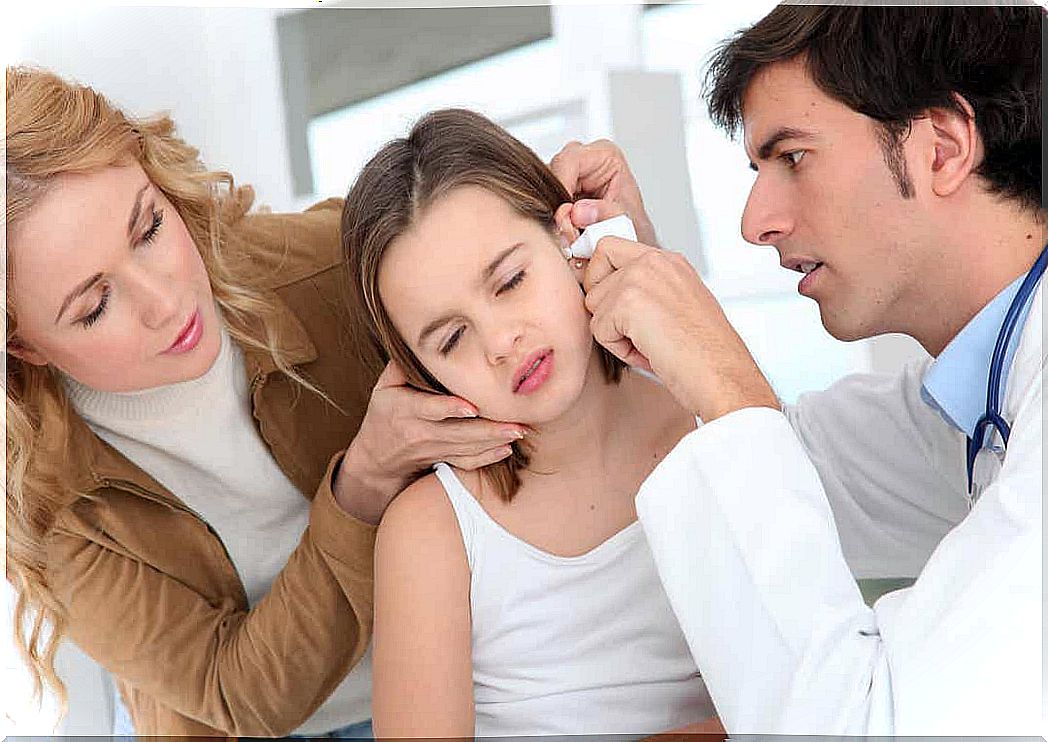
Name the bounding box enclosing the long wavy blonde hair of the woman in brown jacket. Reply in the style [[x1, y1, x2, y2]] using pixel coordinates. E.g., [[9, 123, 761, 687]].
[[3, 67, 315, 708]]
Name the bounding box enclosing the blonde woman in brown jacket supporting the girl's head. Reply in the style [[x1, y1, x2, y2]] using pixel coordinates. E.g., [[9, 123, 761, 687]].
[[5, 68, 520, 736]]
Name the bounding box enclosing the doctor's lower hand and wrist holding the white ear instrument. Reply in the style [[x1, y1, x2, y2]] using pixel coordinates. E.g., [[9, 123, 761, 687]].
[[583, 237, 780, 422]]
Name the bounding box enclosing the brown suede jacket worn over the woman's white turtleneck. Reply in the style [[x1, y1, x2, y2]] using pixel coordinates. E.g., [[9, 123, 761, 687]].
[[47, 199, 385, 736]]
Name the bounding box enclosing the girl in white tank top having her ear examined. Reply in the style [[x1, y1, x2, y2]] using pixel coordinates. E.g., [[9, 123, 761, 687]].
[[343, 110, 713, 737]]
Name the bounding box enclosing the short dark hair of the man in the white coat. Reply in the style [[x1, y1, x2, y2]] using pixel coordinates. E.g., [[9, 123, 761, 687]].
[[705, 5, 1045, 212]]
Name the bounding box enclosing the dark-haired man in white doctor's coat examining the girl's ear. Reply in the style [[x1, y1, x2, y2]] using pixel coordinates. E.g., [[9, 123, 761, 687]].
[[552, 5, 1048, 735]]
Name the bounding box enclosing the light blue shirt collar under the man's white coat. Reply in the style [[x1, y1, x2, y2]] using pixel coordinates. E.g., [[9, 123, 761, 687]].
[[921, 274, 1031, 438]]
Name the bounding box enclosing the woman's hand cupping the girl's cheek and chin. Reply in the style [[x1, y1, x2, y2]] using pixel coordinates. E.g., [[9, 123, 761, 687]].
[[333, 362, 525, 524]]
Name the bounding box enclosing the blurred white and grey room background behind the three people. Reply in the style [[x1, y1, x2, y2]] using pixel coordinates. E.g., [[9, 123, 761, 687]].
[[6, 0, 923, 735]]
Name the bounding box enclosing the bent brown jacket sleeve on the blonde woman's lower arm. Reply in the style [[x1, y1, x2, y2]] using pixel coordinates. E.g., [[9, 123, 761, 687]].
[[48, 455, 375, 736]]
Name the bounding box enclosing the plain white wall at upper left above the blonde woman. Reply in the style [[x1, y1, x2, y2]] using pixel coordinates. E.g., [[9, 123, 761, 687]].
[[5, 5, 293, 211]]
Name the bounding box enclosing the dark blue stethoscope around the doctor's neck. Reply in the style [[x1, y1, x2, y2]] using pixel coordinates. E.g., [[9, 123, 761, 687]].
[[967, 245, 1048, 507]]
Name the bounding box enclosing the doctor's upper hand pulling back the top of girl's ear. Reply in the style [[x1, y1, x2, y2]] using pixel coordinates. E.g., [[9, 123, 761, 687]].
[[549, 139, 656, 244]]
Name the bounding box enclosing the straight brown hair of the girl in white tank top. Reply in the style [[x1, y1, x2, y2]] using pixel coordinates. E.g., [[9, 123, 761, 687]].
[[342, 109, 625, 502]]
